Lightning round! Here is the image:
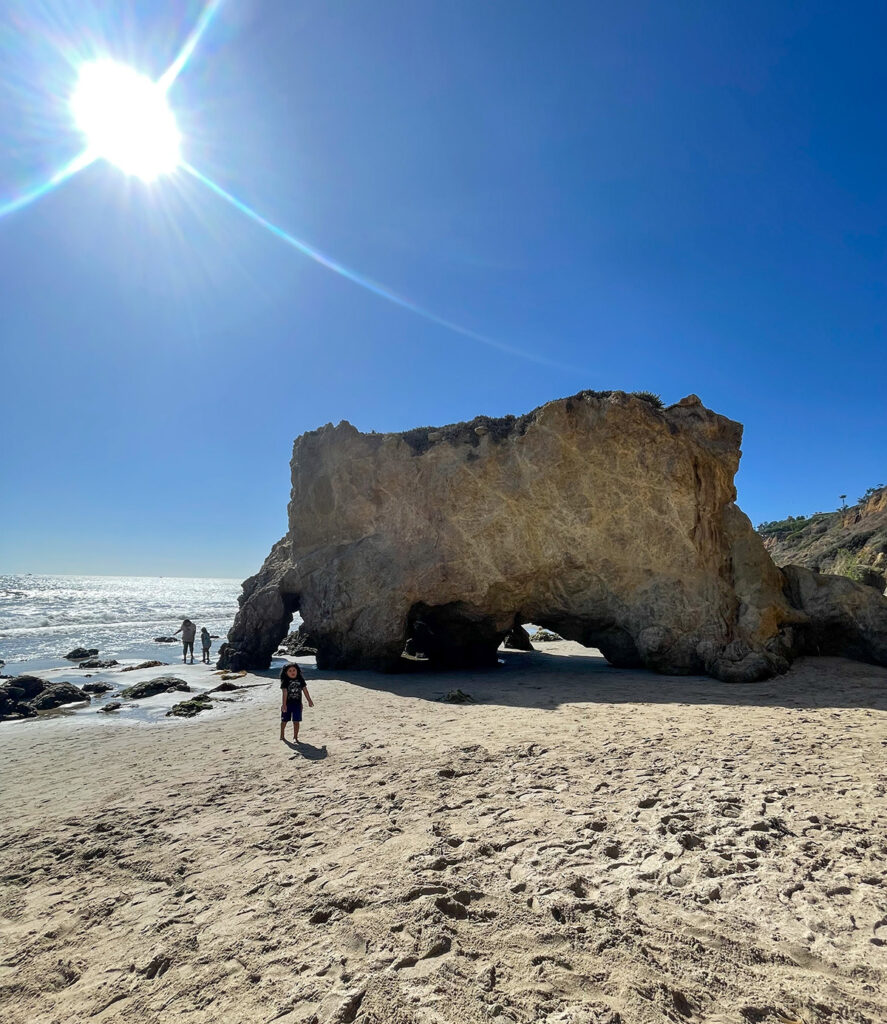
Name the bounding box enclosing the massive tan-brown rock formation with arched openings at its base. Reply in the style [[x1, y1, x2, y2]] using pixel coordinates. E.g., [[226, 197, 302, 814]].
[[220, 391, 887, 682]]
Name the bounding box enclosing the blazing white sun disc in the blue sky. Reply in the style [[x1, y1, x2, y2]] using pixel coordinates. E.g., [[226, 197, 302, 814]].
[[71, 59, 181, 181]]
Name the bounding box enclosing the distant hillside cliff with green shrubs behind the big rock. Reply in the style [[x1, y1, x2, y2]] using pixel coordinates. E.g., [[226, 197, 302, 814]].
[[758, 484, 887, 593]]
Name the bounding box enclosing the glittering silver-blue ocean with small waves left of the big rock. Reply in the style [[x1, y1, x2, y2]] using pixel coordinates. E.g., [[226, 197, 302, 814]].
[[0, 573, 241, 675]]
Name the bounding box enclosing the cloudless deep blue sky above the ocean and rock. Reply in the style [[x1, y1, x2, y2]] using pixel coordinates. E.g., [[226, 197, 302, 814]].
[[0, 0, 887, 577]]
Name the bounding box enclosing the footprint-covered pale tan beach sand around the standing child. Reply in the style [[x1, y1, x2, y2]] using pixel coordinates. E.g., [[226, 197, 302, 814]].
[[0, 643, 887, 1024]]
